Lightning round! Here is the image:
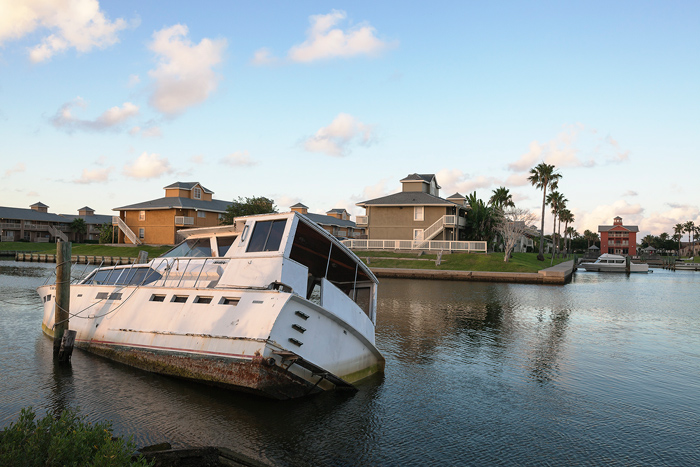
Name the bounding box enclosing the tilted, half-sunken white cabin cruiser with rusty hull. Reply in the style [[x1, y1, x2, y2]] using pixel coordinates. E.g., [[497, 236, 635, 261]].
[[37, 212, 384, 399]]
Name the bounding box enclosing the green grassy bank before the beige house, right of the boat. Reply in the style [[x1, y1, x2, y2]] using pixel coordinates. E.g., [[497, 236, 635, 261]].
[[355, 250, 572, 272]]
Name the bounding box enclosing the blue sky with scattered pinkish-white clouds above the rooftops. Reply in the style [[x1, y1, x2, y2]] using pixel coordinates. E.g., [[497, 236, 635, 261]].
[[0, 0, 700, 241]]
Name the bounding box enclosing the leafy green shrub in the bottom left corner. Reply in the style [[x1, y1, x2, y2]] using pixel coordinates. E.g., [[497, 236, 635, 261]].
[[0, 407, 150, 467]]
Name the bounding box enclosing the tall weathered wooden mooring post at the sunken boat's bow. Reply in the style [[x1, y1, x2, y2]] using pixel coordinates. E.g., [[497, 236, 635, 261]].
[[53, 242, 75, 362]]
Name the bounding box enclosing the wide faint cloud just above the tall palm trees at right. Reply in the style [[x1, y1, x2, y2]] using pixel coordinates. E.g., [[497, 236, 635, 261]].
[[508, 124, 630, 172]]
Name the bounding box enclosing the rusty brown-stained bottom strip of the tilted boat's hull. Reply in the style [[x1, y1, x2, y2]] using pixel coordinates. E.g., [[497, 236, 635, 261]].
[[78, 343, 322, 400]]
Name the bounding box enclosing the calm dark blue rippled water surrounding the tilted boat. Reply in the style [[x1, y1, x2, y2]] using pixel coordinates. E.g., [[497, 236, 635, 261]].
[[0, 261, 700, 466]]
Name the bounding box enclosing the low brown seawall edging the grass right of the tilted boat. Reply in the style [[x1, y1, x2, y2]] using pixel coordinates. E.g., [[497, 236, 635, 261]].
[[371, 260, 574, 285]]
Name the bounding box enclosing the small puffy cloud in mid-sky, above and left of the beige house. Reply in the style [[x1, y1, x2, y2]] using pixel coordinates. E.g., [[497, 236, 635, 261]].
[[304, 113, 375, 156]]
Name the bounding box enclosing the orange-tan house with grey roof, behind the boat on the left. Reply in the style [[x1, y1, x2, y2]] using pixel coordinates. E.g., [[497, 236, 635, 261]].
[[112, 182, 231, 245]]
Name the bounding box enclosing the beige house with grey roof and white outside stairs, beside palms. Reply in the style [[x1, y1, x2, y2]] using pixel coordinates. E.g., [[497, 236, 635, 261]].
[[357, 173, 469, 241]]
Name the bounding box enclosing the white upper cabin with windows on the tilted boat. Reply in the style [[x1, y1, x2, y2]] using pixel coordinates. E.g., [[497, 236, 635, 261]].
[[81, 212, 378, 323]]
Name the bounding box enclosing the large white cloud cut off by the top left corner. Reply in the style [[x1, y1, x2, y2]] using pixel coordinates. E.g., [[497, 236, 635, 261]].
[[0, 0, 128, 63]]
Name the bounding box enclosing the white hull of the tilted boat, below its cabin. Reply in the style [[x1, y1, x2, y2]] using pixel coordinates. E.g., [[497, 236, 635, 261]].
[[38, 285, 384, 399]]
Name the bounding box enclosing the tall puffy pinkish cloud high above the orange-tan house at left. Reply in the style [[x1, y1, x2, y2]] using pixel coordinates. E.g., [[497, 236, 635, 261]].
[[148, 24, 226, 115]]
